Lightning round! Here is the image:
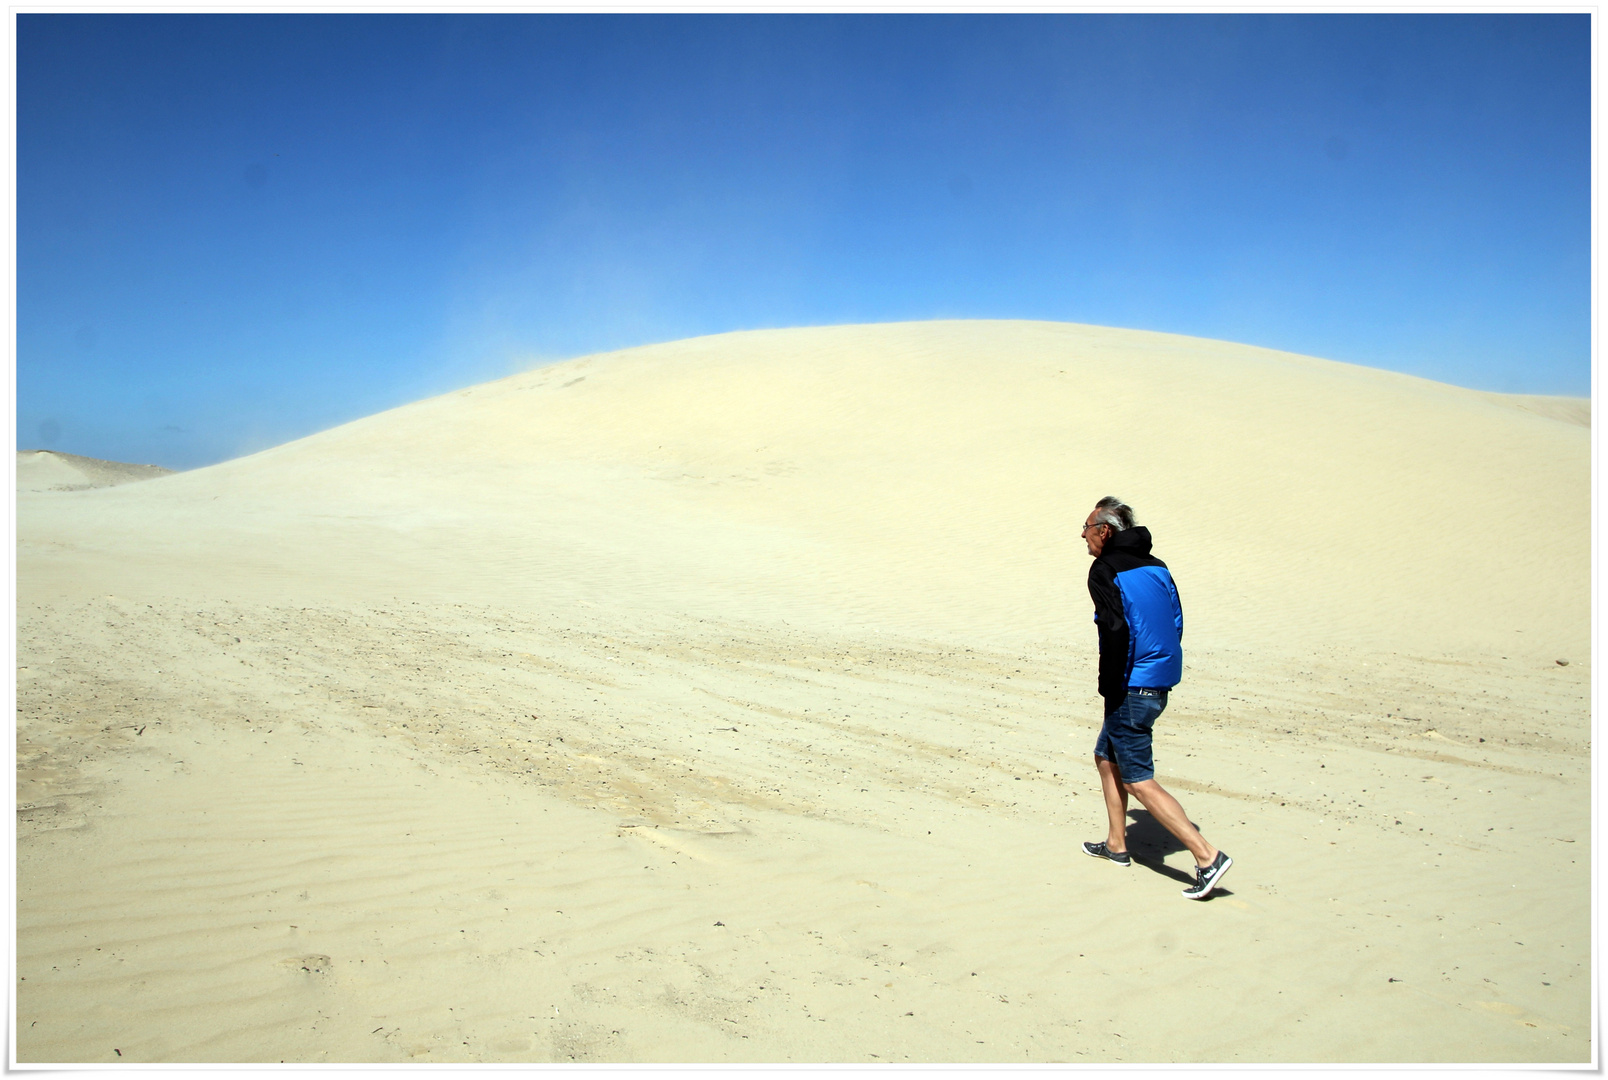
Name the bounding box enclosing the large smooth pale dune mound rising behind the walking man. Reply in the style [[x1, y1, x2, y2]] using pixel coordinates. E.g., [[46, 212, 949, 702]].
[[31, 321, 1590, 657]]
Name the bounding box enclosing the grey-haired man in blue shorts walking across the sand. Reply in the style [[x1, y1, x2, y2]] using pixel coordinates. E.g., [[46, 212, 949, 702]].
[[1084, 495, 1233, 900]]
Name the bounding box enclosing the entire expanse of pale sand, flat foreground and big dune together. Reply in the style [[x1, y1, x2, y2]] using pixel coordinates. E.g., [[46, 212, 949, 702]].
[[14, 323, 1592, 1062]]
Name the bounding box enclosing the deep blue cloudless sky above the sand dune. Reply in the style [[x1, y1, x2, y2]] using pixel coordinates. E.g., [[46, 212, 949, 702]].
[[16, 14, 1592, 468]]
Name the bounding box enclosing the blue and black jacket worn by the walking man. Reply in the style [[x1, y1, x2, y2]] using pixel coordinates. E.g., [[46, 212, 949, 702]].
[[1089, 526, 1183, 712]]
